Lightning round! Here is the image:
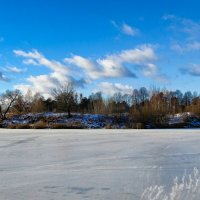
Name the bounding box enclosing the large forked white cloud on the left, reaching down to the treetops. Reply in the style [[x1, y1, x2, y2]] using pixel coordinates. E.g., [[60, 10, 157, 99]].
[[13, 50, 85, 97]]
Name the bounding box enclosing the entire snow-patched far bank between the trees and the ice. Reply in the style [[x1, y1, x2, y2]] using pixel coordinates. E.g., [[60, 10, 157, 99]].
[[0, 112, 200, 129]]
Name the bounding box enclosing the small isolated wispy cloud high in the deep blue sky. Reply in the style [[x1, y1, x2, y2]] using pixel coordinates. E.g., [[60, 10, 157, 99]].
[[111, 20, 140, 36]]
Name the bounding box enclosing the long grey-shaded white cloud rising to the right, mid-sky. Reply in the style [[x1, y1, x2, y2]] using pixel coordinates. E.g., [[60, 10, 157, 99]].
[[64, 45, 158, 79]]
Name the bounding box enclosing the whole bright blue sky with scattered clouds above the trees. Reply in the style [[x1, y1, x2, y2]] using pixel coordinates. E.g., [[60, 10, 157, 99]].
[[0, 0, 200, 96]]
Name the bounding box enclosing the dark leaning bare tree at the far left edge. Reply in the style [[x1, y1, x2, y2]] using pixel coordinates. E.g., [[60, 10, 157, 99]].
[[0, 90, 21, 120]]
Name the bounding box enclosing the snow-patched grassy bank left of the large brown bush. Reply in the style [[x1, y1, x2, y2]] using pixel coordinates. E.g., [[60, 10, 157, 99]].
[[2, 112, 129, 129]]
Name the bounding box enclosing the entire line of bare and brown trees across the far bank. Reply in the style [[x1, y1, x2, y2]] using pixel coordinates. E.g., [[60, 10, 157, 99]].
[[0, 84, 200, 124]]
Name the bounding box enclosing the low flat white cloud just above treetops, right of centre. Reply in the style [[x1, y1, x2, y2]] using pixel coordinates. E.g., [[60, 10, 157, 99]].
[[94, 82, 133, 96]]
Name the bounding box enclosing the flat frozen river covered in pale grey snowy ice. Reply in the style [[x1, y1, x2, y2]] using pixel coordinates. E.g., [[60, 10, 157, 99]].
[[0, 130, 200, 200]]
